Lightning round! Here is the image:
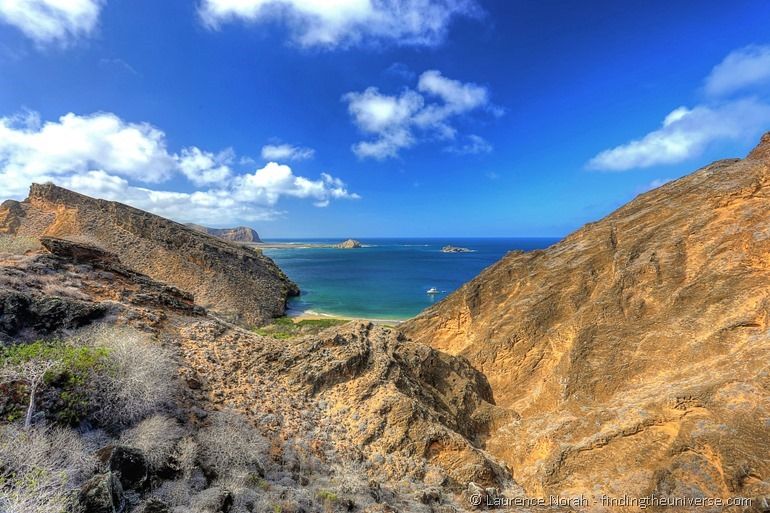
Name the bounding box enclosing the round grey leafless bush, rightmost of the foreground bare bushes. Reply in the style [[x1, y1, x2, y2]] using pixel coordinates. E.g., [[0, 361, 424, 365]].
[[198, 412, 269, 484]]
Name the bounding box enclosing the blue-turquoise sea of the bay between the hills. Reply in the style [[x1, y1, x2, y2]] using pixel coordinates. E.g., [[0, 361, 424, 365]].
[[264, 238, 558, 320]]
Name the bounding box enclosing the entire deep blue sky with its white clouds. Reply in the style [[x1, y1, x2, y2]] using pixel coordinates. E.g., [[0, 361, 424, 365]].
[[0, 0, 770, 238]]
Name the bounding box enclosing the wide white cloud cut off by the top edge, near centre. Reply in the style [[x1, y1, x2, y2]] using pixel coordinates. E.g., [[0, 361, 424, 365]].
[[199, 0, 480, 47]]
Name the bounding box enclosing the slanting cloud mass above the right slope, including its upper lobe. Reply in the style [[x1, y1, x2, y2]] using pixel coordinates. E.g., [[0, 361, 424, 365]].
[[588, 46, 770, 171]]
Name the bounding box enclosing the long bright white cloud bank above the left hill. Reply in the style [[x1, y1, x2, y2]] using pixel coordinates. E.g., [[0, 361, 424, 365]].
[[0, 113, 359, 224]]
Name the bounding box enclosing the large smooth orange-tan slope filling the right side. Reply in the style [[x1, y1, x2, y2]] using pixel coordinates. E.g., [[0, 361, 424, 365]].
[[404, 135, 770, 497]]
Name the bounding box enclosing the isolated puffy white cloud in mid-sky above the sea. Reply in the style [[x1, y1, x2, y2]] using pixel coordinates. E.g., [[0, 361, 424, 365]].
[[343, 70, 495, 159]]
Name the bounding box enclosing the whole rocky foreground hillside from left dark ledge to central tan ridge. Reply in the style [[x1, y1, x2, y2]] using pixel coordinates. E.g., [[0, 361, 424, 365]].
[[0, 237, 512, 513]]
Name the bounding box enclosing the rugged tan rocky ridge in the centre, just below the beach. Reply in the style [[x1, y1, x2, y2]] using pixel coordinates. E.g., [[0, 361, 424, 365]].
[[181, 321, 512, 486]]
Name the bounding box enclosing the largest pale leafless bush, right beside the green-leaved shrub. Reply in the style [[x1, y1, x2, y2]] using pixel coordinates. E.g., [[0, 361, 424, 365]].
[[76, 325, 177, 426]]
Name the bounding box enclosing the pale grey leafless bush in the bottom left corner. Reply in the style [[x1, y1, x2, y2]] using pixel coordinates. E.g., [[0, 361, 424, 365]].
[[0, 425, 95, 513]]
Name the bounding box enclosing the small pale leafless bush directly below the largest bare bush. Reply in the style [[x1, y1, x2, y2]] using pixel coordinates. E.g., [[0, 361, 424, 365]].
[[120, 415, 184, 470]]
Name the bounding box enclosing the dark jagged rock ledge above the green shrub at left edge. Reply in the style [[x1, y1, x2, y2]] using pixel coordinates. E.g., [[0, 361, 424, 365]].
[[0, 237, 205, 342]]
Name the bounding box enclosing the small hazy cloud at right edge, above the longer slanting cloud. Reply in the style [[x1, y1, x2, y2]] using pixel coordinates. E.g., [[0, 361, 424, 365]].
[[705, 45, 770, 96]]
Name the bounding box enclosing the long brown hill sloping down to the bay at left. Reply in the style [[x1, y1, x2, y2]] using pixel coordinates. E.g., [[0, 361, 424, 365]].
[[0, 184, 299, 324]]
